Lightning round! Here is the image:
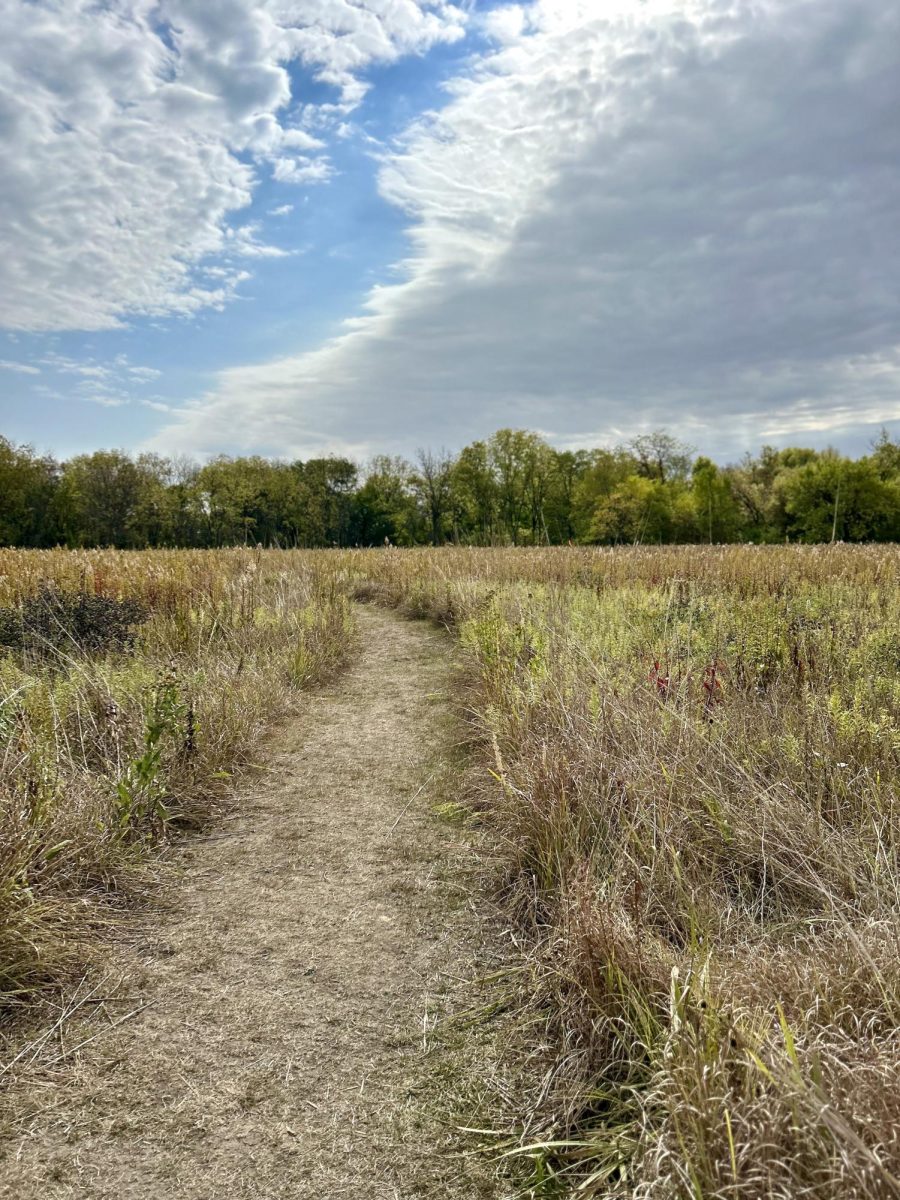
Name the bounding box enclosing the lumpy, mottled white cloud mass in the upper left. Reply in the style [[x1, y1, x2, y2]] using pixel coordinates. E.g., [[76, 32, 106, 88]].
[[0, 0, 464, 331]]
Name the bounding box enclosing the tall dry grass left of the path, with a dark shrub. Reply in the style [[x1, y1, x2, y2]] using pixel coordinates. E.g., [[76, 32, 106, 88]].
[[0, 550, 352, 1014]]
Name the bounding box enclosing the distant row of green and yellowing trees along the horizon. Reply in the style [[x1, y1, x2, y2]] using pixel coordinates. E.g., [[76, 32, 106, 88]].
[[0, 430, 900, 548]]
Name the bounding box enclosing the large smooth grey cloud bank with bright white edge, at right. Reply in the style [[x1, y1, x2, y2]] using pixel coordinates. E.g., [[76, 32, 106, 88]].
[[156, 0, 900, 454]]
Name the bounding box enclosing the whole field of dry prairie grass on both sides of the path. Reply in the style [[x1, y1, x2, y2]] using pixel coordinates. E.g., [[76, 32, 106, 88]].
[[0, 545, 900, 1200]]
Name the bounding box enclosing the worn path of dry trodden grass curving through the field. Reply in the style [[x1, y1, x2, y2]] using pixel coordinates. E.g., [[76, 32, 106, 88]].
[[0, 607, 501, 1200]]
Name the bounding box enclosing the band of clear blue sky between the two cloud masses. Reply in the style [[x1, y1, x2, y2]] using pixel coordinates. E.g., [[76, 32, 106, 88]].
[[1, 76, 415, 452]]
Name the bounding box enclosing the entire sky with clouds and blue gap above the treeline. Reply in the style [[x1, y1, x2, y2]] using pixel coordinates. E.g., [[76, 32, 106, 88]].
[[0, 0, 900, 462]]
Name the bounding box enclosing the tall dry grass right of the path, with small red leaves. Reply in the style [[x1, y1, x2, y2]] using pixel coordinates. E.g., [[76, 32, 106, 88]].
[[343, 547, 900, 1200]]
